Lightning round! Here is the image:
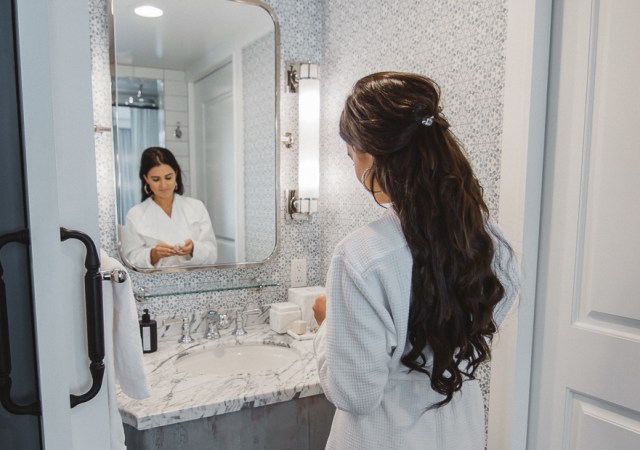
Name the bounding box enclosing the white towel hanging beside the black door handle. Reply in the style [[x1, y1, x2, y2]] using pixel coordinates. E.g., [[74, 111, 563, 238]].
[[100, 249, 150, 450]]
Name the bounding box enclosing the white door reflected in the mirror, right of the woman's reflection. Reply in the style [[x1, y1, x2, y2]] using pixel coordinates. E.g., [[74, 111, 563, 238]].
[[193, 62, 241, 263]]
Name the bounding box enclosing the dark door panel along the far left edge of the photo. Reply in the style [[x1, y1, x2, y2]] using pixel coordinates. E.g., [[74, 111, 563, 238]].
[[0, 0, 42, 450]]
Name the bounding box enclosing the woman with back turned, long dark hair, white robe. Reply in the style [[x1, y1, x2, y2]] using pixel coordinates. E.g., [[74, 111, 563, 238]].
[[314, 72, 518, 450]]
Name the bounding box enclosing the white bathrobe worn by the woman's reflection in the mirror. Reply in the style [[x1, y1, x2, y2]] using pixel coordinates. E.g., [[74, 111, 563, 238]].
[[122, 194, 218, 268]]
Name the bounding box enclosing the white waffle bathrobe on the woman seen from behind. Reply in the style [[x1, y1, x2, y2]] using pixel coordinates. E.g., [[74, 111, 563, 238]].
[[314, 210, 517, 450]]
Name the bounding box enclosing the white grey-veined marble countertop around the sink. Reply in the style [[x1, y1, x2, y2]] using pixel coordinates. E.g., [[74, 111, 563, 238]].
[[117, 325, 322, 430]]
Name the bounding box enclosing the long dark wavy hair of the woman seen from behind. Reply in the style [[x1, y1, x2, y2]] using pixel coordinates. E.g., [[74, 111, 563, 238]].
[[340, 72, 505, 408]]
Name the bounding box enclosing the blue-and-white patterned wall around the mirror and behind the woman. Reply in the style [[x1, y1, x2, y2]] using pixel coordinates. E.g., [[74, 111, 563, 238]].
[[91, 0, 507, 442]]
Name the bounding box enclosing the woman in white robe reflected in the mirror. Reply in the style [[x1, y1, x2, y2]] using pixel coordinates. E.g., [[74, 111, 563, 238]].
[[122, 147, 218, 268]]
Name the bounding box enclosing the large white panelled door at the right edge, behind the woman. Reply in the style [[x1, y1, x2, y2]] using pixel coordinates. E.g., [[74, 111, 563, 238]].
[[528, 0, 640, 450]]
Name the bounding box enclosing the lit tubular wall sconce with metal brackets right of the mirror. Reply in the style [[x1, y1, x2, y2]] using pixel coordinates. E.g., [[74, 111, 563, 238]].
[[286, 62, 320, 220]]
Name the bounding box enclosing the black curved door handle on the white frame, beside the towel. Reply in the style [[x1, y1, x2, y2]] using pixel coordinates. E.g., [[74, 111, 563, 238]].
[[60, 227, 104, 408]]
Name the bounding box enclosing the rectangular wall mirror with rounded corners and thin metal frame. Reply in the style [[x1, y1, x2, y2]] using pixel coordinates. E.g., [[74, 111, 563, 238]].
[[111, 0, 280, 272]]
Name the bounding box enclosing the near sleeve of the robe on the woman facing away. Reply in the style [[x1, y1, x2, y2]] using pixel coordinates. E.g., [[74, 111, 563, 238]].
[[314, 250, 395, 415]]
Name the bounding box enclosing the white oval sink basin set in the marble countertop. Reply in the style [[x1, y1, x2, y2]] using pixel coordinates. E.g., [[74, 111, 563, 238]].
[[175, 344, 300, 375]]
